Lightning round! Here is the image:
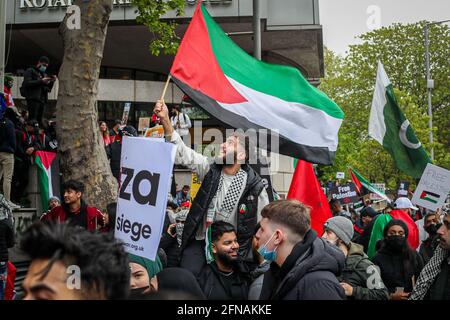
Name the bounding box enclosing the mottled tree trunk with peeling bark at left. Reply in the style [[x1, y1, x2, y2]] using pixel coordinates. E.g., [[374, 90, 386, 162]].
[[56, 0, 117, 210]]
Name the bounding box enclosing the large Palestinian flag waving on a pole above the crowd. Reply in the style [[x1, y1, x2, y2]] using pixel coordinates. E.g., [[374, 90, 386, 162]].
[[170, 3, 344, 164]]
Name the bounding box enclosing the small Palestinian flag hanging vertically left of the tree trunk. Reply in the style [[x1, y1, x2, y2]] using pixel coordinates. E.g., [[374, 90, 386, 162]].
[[34, 151, 59, 211]]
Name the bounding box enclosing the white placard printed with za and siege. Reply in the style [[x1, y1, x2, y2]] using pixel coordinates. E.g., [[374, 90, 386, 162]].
[[114, 136, 176, 260]]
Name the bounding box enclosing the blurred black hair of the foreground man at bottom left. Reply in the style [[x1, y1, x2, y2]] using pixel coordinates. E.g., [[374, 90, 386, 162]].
[[20, 221, 130, 300]]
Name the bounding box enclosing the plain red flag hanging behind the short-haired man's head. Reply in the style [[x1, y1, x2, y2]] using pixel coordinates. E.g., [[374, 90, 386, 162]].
[[287, 160, 332, 237]]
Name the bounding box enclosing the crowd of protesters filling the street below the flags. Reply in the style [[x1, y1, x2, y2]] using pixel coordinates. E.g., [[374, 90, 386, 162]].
[[0, 96, 450, 300]]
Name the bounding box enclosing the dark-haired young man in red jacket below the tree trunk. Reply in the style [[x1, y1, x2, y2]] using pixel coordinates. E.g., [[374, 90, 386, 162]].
[[41, 180, 105, 231]]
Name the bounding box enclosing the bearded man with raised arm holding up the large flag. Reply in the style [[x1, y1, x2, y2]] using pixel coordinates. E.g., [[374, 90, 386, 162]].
[[154, 101, 269, 275]]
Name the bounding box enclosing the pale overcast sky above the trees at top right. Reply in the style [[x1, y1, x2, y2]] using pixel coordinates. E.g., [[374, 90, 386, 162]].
[[319, 0, 450, 54]]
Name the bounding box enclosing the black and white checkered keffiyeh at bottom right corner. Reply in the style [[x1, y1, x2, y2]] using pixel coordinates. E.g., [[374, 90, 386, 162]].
[[408, 246, 449, 300]]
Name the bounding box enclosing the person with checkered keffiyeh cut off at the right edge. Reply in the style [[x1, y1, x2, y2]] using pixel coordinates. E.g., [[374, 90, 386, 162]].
[[409, 212, 450, 300]]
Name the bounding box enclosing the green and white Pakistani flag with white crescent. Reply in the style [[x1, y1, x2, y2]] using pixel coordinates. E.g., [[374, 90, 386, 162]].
[[369, 62, 431, 179]]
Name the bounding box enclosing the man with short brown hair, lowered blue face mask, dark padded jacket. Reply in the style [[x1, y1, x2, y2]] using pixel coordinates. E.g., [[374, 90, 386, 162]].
[[256, 200, 345, 300]]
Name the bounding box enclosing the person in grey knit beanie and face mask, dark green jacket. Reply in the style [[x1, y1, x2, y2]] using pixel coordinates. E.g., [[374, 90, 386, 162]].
[[322, 216, 389, 300]]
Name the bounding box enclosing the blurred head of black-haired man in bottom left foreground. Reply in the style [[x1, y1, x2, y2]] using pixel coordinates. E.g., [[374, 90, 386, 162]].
[[21, 222, 130, 300]]
